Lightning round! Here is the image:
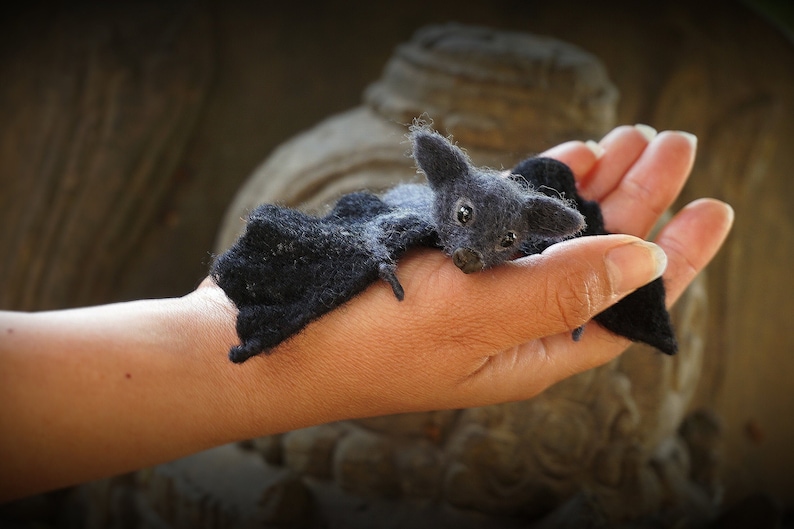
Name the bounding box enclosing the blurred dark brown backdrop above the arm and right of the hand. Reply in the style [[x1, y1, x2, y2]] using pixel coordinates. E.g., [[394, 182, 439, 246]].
[[0, 0, 794, 524]]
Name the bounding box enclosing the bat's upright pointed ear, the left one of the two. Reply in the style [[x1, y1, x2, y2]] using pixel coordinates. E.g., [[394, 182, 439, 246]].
[[411, 129, 470, 189]]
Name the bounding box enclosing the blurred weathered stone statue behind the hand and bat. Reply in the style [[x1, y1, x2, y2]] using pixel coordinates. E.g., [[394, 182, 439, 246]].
[[201, 25, 719, 526]]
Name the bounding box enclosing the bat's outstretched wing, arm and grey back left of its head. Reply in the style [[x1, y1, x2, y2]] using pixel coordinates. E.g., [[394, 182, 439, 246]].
[[211, 193, 435, 363]]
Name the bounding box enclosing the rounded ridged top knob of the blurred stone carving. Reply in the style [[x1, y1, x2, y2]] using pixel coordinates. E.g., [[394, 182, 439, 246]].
[[365, 24, 618, 152]]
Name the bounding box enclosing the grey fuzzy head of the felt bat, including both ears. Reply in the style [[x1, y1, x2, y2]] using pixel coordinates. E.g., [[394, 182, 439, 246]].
[[411, 128, 584, 274]]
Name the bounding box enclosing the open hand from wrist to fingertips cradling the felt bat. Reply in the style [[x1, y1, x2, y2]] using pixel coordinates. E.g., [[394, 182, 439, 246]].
[[193, 127, 732, 434]]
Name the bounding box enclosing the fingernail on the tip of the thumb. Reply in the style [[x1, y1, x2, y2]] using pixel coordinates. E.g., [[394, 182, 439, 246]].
[[606, 241, 667, 295]]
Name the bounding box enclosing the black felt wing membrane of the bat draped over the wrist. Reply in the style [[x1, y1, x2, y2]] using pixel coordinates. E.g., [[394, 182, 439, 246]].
[[211, 205, 378, 363]]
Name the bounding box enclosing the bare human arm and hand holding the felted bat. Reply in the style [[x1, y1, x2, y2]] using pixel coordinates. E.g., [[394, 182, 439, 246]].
[[0, 126, 733, 501]]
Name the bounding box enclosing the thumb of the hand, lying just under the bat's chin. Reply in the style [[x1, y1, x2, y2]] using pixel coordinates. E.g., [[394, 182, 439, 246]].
[[436, 235, 667, 350]]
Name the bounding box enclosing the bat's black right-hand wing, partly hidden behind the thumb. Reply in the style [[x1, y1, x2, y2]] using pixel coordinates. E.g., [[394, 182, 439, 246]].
[[511, 157, 678, 355]]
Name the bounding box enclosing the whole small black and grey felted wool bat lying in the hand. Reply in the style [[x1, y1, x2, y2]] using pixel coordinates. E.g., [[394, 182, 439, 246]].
[[210, 127, 676, 363]]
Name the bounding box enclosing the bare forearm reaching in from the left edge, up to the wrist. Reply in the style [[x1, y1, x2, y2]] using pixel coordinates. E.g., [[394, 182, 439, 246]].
[[0, 288, 256, 498]]
